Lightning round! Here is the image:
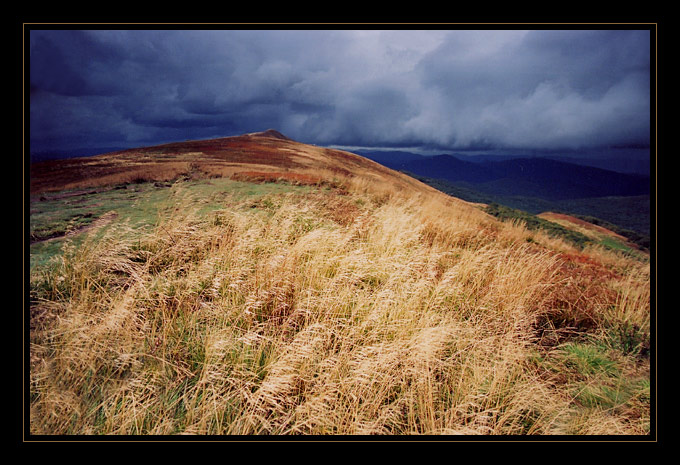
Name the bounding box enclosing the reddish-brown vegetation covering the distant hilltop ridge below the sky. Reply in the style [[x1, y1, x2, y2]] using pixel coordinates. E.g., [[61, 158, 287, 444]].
[[30, 130, 394, 195]]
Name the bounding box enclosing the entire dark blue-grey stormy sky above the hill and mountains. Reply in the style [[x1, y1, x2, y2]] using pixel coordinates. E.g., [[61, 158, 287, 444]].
[[28, 30, 650, 157]]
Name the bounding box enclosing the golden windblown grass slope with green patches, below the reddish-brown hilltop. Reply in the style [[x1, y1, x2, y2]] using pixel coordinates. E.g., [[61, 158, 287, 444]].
[[26, 133, 652, 435]]
